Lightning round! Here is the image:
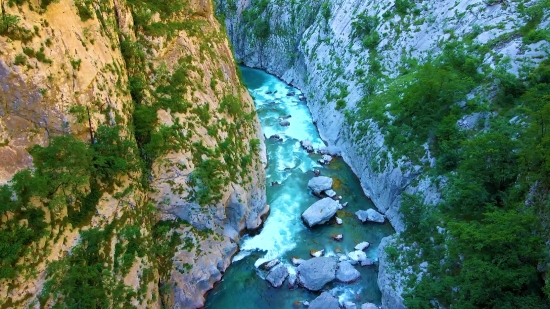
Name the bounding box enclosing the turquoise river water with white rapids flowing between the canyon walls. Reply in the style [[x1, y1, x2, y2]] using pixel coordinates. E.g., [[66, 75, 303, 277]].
[[205, 67, 394, 309]]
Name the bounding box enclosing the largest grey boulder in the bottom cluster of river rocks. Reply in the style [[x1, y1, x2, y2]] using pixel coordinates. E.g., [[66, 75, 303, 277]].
[[296, 257, 336, 291]]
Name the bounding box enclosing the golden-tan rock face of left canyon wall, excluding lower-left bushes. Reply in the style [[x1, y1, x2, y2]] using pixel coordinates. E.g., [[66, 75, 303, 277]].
[[0, 0, 269, 308]]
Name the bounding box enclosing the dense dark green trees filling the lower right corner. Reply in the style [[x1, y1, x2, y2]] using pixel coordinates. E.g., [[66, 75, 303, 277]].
[[402, 60, 550, 309]]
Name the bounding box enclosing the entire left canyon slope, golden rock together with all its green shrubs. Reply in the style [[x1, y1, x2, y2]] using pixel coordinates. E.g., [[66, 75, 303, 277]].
[[0, 0, 269, 308]]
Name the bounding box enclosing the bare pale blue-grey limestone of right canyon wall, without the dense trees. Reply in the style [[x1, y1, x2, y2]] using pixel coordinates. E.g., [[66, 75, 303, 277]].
[[218, 0, 550, 308]]
